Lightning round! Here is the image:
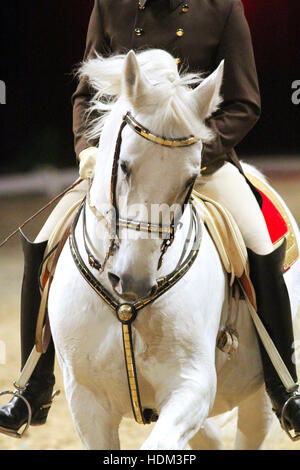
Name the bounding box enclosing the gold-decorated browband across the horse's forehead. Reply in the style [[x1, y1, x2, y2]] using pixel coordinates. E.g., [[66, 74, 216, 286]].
[[124, 111, 200, 147]]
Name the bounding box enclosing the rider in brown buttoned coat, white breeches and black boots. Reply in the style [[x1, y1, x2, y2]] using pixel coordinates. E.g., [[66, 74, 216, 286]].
[[0, 0, 300, 433]]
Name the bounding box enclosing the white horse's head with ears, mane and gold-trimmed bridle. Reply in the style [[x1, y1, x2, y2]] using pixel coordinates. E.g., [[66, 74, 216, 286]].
[[81, 50, 223, 301]]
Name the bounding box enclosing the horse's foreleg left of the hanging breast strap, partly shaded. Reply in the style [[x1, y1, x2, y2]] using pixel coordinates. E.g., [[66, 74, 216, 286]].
[[64, 372, 121, 450]]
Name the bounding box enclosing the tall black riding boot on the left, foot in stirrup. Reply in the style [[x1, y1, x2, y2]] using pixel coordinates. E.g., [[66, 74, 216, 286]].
[[0, 233, 55, 436]]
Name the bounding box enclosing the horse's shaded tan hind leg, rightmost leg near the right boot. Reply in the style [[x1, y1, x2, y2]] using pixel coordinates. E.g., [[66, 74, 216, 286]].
[[234, 386, 272, 450]]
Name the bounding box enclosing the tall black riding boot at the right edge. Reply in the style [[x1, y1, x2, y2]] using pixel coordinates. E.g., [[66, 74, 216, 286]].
[[248, 241, 300, 435]]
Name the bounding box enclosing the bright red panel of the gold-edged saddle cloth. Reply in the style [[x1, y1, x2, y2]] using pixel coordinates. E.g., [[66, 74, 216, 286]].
[[256, 188, 288, 243]]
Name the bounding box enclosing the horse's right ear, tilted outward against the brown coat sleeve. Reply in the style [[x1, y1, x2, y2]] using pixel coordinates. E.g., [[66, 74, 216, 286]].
[[192, 60, 224, 121]]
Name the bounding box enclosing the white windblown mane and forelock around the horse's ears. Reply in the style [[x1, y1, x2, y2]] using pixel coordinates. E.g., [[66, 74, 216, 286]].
[[79, 49, 219, 142]]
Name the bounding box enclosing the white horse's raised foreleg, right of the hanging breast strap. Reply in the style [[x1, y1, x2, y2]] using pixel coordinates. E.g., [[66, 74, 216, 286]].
[[141, 375, 215, 450]]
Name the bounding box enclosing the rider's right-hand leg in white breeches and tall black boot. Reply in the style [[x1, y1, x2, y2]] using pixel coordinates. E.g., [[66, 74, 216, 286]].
[[197, 163, 300, 433]]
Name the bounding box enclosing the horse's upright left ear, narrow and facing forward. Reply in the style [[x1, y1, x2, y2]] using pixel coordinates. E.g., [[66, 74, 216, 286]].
[[123, 51, 149, 105]]
